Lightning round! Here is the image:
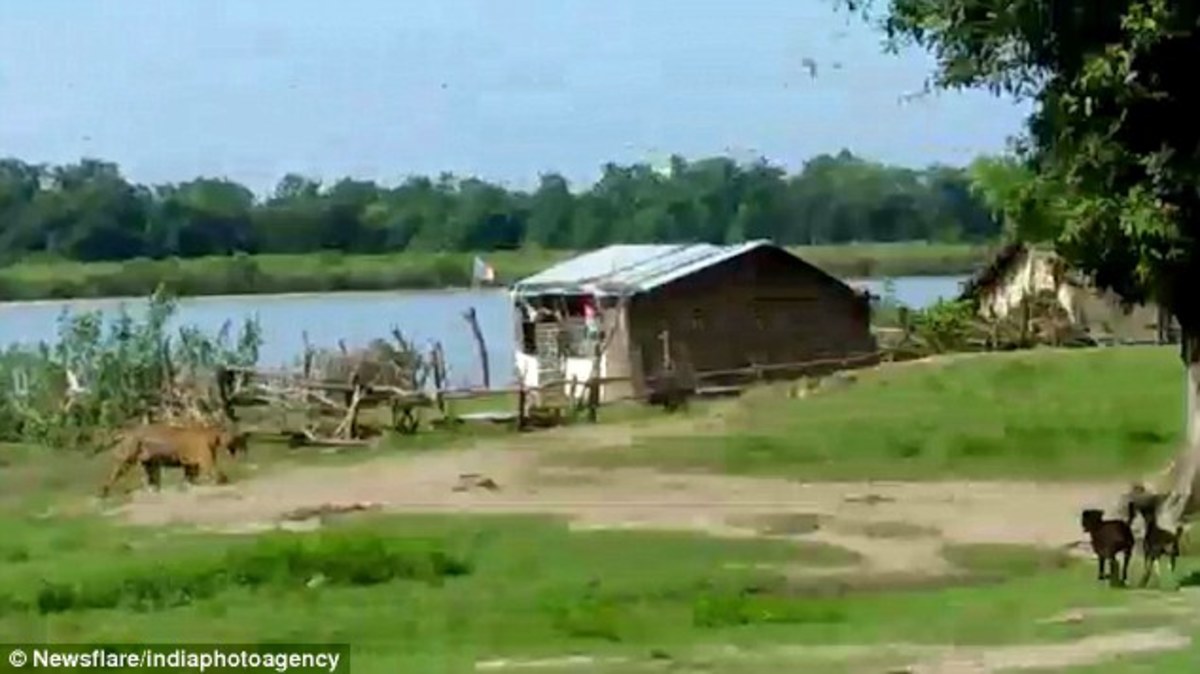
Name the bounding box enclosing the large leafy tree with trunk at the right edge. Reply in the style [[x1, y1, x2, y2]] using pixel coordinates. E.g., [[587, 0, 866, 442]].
[[847, 0, 1200, 513]]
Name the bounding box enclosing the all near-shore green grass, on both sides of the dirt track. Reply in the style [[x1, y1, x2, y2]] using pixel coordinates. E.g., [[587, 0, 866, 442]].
[[0, 348, 1200, 674]]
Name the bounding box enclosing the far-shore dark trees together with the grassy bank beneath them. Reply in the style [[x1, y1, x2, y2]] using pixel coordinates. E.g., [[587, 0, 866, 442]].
[[0, 152, 1000, 300]]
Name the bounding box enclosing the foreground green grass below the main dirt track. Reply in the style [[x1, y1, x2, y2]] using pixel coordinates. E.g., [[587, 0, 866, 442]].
[[0, 508, 1180, 672]]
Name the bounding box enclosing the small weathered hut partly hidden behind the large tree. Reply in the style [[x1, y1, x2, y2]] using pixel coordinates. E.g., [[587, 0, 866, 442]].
[[961, 243, 1175, 343]]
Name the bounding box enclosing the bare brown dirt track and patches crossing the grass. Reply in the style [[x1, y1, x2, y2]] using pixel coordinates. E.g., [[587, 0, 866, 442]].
[[100, 420, 1200, 674]]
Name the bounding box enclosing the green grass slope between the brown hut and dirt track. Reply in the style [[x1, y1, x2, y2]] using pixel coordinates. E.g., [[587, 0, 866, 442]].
[[559, 347, 1183, 480]]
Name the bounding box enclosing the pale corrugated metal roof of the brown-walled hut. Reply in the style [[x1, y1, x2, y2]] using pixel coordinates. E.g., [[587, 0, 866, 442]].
[[512, 240, 774, 295]]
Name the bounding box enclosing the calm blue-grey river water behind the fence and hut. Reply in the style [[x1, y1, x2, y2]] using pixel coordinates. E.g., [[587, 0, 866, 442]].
[[0, 276, 965, 385]]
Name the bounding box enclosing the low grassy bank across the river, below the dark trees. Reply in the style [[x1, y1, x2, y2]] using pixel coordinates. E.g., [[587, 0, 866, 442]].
[[0, 243, 991, 301]]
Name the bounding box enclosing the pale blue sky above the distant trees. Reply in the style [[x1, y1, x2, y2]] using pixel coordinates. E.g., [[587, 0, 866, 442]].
[[0, 0, 1028, 194]]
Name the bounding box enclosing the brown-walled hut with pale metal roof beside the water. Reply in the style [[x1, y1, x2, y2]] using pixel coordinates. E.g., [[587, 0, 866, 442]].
[[511, 241, 875, 402]]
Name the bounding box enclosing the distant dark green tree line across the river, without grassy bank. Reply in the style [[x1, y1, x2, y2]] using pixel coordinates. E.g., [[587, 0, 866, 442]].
[[0, 151, 1001, 261]]
